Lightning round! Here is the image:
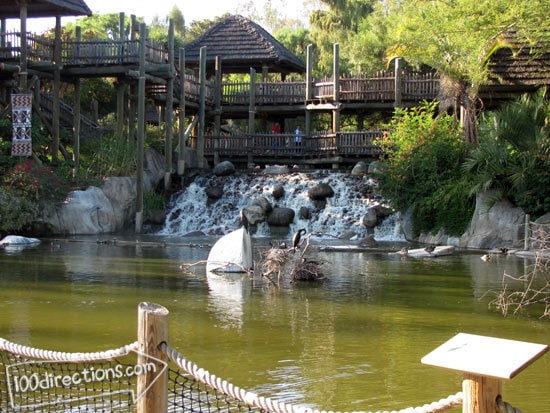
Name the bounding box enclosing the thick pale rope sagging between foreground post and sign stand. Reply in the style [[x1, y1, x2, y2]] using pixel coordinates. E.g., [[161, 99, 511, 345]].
[[161, 343, 463, 413]]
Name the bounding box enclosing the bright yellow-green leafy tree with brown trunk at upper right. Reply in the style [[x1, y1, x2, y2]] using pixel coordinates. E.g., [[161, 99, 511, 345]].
[[377, 0, 550, 144]]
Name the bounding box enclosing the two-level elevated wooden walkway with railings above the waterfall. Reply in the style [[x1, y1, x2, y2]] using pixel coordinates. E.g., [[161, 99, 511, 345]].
[[0, 25, 439, 165]]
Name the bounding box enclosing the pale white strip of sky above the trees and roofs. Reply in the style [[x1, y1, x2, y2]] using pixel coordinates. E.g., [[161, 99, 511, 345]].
[[8, 0, 307, 33]]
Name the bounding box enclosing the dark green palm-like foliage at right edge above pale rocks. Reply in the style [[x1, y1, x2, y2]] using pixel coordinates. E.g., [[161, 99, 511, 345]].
[[464, 90, 550, 218]]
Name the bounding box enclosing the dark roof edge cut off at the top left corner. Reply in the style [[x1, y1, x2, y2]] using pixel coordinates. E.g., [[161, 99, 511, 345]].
[[0, 0, 92, 19]]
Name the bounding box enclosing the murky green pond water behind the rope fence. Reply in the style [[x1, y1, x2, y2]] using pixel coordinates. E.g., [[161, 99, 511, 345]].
[[0, 236, 550, 413]]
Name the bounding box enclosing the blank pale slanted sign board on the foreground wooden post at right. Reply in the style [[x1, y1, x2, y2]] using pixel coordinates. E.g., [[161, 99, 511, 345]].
[[421, 333, 548, 379]]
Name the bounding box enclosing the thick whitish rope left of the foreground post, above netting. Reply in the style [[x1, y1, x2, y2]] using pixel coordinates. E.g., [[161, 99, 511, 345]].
[[0, 338, 138, 363]]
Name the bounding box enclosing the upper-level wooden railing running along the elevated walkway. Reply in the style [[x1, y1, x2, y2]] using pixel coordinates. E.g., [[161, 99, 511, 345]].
[[0, 32, 439, 111]]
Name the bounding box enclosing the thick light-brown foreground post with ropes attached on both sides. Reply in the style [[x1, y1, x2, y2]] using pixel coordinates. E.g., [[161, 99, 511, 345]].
[[137, 302, 169, 413]]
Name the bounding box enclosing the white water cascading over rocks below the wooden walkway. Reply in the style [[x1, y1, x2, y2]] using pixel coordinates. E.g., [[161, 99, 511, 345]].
[[160, 171, 403, 241]]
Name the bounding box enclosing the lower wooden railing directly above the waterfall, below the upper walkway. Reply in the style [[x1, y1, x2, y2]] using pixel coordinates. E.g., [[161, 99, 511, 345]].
[[204, 130, 384, 158]]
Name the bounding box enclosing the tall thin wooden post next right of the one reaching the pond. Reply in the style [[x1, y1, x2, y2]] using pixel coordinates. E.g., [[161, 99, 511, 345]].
[[164, 19, 175, 189]]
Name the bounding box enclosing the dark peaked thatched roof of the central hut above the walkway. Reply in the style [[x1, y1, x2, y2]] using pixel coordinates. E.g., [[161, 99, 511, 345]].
[[185, 15, 306, 74]]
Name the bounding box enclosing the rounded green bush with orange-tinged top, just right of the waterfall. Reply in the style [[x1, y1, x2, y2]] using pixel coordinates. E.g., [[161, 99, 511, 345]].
[[378, 102, 474, 235]]
